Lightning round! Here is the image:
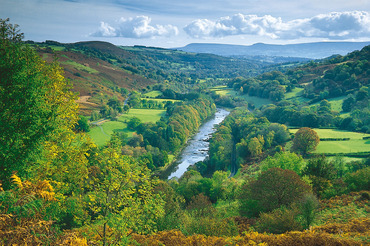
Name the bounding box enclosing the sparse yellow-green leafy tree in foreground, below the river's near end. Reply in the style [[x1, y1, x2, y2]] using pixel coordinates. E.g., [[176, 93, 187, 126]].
[[86, 135, 163, 245]]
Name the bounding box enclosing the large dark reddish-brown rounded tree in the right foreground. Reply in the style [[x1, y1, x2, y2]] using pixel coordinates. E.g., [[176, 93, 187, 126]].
[[240, 168, 310, 216]]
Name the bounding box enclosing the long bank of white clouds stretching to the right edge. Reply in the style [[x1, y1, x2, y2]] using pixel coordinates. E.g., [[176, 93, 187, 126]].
[[184, 11, 370, 39]]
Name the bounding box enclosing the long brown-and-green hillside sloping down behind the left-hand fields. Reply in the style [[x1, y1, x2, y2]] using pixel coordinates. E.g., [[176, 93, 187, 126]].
[[32, 41, 264, 114]]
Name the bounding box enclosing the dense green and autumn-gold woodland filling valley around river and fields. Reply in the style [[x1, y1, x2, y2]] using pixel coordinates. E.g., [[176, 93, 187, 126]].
[[0, 19, 370, 245]]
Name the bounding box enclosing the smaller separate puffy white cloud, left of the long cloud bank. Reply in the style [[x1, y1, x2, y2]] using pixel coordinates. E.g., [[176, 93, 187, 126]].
[[91, 16, 179, 38]]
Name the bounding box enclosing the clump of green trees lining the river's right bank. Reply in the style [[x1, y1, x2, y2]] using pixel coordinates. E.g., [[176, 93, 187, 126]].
[[196, 109, 290, 175]]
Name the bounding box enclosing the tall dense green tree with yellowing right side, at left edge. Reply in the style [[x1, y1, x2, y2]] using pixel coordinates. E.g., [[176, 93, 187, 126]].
[[0, 24, 78, 188]]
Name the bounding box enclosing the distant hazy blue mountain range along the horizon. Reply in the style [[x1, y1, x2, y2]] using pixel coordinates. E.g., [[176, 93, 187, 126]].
[[177, 41, 370, 59]]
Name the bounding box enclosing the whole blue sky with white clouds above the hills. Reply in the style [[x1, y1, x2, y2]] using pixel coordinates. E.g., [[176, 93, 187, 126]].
[[0, 0, 370, 48]]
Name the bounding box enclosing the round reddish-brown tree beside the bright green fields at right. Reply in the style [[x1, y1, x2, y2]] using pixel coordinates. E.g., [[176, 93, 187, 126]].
[[292, 127, 320, 155]]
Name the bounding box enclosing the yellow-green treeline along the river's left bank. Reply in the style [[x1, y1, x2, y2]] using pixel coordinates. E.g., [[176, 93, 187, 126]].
[[123, 95, 216, 170]]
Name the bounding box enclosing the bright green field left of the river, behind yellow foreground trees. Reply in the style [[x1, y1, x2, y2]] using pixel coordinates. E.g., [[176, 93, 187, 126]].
[[89, 109, 166, 146]]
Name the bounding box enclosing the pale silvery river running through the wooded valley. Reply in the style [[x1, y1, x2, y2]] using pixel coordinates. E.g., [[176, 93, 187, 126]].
[[168, 108, 230, 179]]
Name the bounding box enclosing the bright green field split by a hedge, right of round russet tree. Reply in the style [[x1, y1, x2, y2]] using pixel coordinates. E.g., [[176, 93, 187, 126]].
[[289, 129, 370, 154]]
